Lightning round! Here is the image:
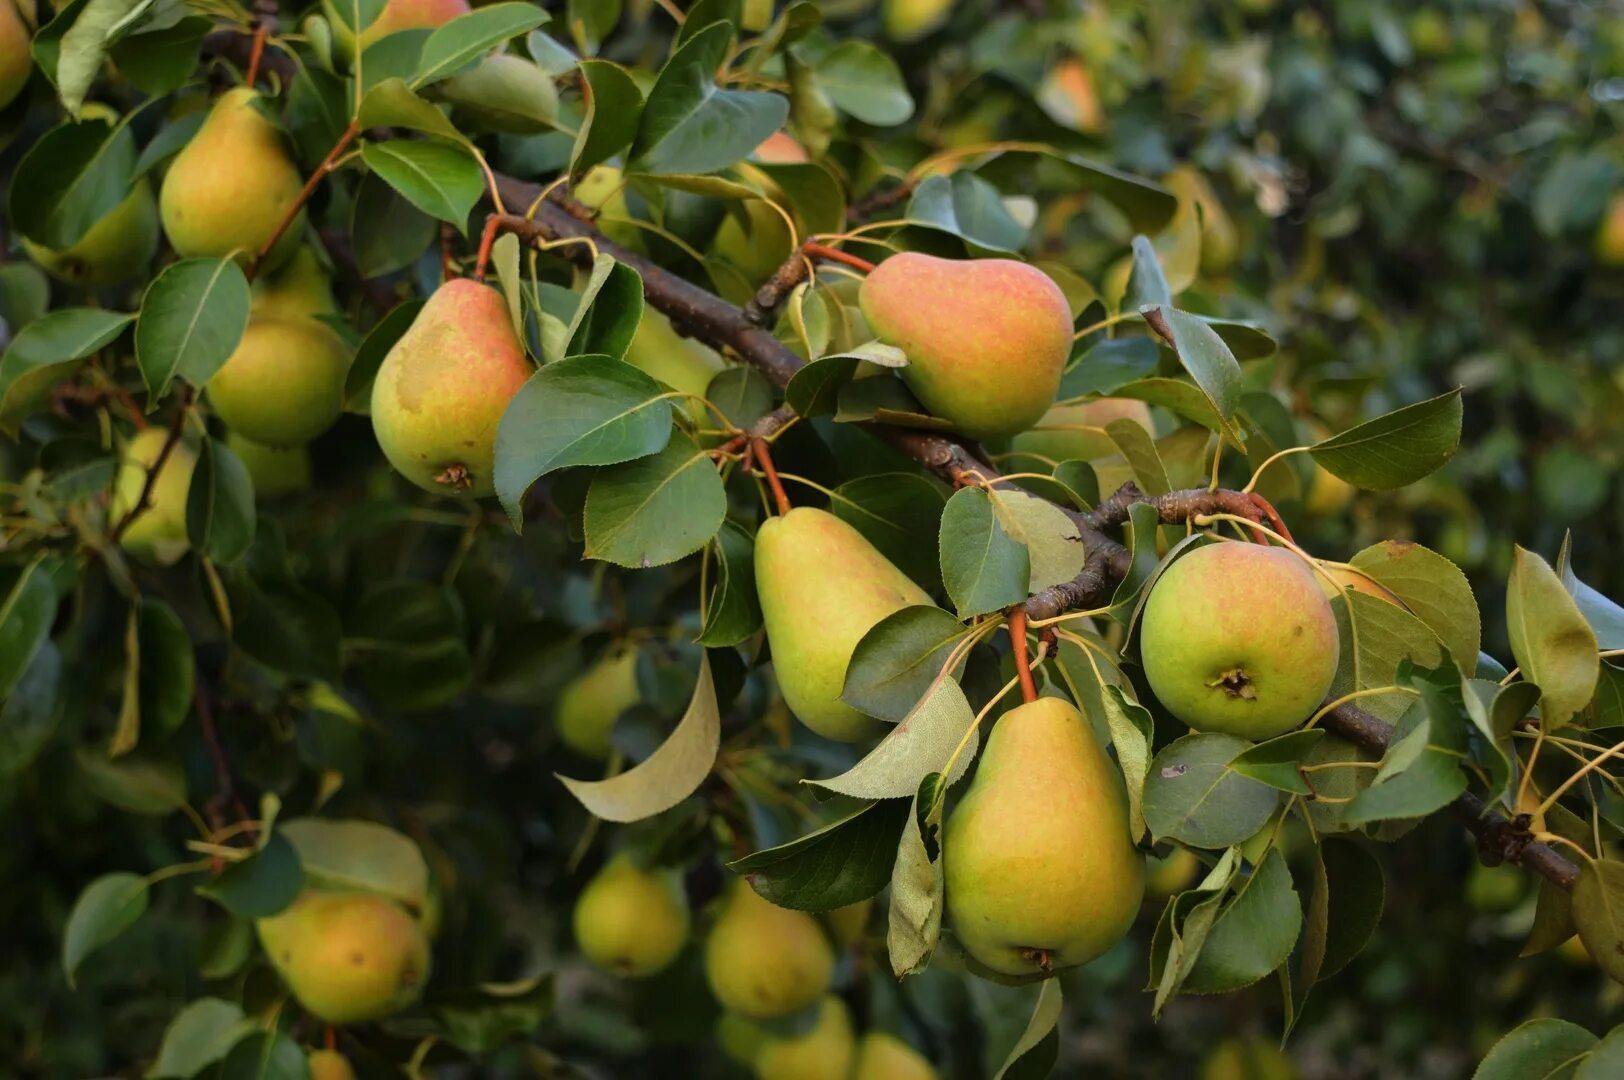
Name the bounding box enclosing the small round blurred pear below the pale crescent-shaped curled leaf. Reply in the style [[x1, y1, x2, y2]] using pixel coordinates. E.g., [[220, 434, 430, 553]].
[[575, 853, 689, 979]]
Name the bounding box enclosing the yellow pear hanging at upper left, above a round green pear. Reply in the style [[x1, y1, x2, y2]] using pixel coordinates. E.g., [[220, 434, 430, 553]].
[[158, 86, 304, 266]]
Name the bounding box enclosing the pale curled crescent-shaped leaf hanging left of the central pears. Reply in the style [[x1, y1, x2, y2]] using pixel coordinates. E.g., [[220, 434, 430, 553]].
[[554, 653, 721, 822]]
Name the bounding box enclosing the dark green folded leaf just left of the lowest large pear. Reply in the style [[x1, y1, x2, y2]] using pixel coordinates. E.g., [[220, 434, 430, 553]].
[[728, 799, 909, 911]]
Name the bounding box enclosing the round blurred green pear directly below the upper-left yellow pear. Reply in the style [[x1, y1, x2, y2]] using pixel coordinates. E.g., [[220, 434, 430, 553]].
[[208, 315, 349, 447]]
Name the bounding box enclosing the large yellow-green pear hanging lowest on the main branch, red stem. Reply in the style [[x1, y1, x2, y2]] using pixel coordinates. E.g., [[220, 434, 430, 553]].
[[942, 697, 1145, 974]]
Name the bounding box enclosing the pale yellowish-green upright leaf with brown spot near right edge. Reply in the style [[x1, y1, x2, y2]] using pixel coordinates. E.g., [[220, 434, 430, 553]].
[[1505, 547, 1601, 728]]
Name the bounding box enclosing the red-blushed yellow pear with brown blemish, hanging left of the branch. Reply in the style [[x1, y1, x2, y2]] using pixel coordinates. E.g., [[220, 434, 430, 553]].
[[372, 279, 536, 499]]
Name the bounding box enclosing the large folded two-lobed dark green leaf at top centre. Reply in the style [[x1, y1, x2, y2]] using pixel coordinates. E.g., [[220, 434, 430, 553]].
[[630, 23, 789, 174]]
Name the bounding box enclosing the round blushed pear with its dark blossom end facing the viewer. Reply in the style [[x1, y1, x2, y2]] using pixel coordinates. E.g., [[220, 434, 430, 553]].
[[1138, 542, 1338, 739]]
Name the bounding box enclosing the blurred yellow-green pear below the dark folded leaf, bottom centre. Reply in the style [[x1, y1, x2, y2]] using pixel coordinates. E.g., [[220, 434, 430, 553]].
[[705, 880, 835, 1020]]
